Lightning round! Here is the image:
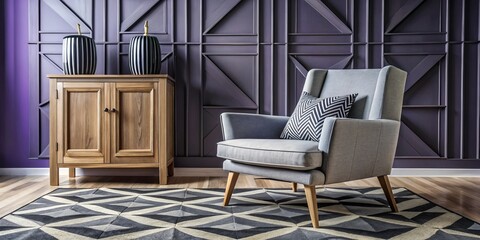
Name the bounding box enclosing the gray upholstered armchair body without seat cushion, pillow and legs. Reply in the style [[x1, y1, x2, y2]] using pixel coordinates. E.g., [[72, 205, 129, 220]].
[[220, 66, 407, 184]]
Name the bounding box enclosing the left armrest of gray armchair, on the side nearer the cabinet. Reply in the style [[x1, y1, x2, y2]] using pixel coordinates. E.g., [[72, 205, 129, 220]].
[[220, 113, 289, 140]]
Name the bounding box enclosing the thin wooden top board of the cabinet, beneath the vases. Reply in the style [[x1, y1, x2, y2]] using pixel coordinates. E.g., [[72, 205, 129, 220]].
[[47, 74, 175, 81]]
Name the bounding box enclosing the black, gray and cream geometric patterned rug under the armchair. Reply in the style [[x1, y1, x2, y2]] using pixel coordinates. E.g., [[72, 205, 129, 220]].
[[0, 187, 480, 240]]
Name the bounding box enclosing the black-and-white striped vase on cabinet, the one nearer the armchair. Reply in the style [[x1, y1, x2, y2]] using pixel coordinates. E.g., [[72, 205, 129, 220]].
[[128, 36, 162, 75]]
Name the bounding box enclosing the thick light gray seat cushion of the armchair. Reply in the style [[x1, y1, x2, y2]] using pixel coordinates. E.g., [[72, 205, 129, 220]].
[[217, 139, 322, 170]]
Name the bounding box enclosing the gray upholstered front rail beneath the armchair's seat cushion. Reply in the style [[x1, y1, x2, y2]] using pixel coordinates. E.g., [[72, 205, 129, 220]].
[[223, 160, 325, 185]]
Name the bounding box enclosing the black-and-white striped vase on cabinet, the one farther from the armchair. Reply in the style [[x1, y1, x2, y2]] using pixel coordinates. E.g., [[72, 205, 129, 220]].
[[62, 35, 97, 75]]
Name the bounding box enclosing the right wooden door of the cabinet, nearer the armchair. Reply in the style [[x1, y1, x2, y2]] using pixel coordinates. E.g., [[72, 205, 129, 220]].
[[111, 83, 158, 164]]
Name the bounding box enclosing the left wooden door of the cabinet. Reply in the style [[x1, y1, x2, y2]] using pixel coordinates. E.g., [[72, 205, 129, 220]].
[[57, 83, 106, 163]]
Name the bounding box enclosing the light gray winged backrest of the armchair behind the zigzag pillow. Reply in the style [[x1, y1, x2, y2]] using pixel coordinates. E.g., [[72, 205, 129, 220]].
[[303, 66, 407, 121]]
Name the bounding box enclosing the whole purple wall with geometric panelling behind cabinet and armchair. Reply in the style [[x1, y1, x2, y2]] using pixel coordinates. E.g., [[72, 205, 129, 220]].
[[0, 0, 480, 168]]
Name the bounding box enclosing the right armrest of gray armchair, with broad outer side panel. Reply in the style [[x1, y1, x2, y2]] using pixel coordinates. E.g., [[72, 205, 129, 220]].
[[318, 118, 400, 184]]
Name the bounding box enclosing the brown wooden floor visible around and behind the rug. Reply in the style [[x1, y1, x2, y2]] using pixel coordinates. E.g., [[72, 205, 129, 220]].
[[0, 175, 480, 222]]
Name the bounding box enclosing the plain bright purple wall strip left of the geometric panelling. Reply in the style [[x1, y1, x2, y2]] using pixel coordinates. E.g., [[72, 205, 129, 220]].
[[0, 0, 48, 167]]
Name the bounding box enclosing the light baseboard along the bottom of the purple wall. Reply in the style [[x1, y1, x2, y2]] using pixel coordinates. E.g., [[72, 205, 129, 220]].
[[0, 168, 480, 177]]
